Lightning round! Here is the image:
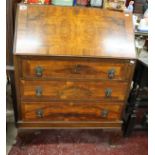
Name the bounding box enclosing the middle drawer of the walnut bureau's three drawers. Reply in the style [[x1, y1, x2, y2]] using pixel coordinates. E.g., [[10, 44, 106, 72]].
[[21, 80, 128, 101]]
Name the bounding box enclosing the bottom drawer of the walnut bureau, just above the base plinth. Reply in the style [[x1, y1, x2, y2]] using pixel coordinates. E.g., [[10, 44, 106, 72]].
[[21, 101, 123, 121]]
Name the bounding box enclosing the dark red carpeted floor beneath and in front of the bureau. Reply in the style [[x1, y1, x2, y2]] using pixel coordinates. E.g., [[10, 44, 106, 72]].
[[8, 129, 148, 155]]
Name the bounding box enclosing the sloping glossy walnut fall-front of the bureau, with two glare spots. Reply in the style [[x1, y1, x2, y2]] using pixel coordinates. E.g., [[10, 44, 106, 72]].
[[14, 4, 135, 58]]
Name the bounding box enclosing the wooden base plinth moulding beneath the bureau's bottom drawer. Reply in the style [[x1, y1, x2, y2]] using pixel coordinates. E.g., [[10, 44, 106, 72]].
[[17, 121, 122, 131]]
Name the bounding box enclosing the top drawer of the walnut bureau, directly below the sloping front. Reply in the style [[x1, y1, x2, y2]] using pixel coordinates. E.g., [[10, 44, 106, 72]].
[[22, 59, 131, 80]]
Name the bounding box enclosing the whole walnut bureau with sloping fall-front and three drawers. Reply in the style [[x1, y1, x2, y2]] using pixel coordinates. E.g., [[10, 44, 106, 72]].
[[14, 4, 135, 130]]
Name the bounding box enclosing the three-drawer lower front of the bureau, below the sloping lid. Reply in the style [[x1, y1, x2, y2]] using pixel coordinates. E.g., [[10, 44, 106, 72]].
[[15, 55, 135, 129]]
